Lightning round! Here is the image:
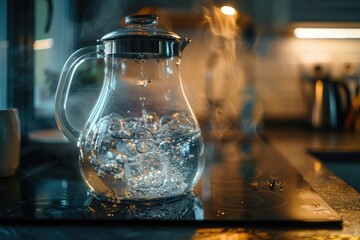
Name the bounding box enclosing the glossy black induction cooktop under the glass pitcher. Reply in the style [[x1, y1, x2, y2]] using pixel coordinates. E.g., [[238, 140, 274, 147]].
[[0, 138, 342, 228]]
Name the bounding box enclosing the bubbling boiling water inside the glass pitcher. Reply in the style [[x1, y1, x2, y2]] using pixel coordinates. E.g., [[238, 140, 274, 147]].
[[80, 113, 204, 201]]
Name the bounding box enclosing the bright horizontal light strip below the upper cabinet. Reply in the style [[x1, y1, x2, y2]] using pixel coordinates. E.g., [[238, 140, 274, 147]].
[[294, 28, 360, 39]]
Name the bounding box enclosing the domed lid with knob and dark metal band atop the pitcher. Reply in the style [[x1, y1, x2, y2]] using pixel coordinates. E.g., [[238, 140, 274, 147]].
[[99, 15, 190, 58]]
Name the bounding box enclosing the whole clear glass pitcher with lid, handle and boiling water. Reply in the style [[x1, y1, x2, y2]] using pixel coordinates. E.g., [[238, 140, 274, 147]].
[[55, 15, 204, 202]]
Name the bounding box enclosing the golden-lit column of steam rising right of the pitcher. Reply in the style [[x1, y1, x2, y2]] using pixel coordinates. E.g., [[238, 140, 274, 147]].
[[204, 3, 244, 137]]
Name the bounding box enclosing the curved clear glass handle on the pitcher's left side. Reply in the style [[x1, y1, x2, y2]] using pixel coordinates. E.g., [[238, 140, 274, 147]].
[[55, 45, 104, 142]]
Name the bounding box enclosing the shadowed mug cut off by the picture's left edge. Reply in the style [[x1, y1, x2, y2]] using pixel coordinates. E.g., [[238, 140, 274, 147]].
[[0, 108, 20, 177]]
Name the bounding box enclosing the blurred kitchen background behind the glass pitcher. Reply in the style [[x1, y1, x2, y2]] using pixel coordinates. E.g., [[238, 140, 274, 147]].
[[0, 0, 360, 139]]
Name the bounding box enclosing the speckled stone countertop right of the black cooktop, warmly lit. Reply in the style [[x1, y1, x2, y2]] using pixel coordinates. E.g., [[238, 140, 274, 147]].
[[265, 126, 360, 239]]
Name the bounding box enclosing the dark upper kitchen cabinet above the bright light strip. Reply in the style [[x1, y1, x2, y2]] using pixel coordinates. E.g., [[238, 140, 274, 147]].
[[245, 0, 360, 31]]
